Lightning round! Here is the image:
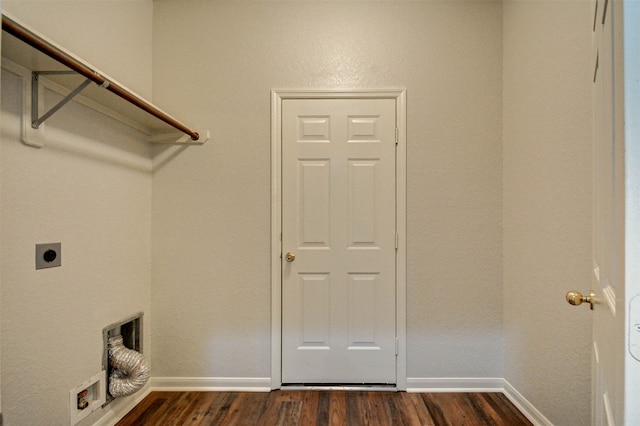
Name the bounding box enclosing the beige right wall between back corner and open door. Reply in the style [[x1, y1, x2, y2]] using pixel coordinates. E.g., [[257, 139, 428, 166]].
[[503, 1, 593, 426]]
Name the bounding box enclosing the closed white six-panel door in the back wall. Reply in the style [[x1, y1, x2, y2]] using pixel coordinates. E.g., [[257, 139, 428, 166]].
[[281, 99, 396, 384]]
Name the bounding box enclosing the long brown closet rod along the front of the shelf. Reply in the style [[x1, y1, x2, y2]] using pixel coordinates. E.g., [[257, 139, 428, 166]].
[[2, 15, 200, 141]]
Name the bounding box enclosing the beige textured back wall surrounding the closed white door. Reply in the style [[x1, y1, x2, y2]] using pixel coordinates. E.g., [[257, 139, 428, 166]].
[[152, 1, 503, 377]]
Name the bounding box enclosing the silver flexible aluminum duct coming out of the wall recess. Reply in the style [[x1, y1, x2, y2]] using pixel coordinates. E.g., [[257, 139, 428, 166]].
[[109, 336, 151, 398]]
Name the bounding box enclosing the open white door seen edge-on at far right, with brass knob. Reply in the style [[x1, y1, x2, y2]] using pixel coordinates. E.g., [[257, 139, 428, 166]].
[[592, 0, 631, 426]]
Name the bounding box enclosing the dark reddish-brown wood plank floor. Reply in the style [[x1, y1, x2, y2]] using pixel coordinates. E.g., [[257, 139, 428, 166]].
[[116, 391, 532, 426]]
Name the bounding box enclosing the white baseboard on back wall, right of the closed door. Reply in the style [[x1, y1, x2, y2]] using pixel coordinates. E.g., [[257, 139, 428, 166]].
[[407, 377, 504, 392]]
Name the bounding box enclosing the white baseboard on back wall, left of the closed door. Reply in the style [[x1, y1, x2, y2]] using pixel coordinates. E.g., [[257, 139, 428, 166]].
[[149, 377, 271, 392]]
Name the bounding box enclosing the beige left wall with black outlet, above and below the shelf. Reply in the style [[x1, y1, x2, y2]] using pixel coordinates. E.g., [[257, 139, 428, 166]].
[[0, 1, 151, 426]]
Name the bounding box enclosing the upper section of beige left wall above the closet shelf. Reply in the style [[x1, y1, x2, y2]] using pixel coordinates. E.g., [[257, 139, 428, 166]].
[[2, 0, 153, 98]]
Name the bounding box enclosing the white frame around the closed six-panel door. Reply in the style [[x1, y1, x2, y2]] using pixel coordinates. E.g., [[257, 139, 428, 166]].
[[271, 89, 407, 390]]
